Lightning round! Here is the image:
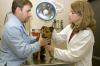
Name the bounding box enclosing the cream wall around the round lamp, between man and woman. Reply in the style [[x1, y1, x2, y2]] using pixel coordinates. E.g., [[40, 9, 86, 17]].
[[30, 0, 70, 29]]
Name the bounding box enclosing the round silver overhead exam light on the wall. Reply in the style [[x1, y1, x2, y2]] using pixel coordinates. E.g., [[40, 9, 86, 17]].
[[36, 2, 56, 21]]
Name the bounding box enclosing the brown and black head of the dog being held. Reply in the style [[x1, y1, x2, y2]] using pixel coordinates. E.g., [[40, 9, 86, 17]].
[[40, 26, 54, 39]]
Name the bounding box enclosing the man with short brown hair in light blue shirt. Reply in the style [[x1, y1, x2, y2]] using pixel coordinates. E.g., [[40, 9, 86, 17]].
[[0, 0, 49, 66]]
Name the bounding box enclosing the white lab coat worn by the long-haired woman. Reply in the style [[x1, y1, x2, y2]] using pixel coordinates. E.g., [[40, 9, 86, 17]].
[[52, 25, 95, 66]]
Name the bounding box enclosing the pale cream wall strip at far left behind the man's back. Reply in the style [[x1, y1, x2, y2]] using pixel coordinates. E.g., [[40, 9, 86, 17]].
[[0, 0, 13, 38]]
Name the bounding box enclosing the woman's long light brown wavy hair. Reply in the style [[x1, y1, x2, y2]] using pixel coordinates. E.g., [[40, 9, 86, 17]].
[[71, 1, 96, 32]]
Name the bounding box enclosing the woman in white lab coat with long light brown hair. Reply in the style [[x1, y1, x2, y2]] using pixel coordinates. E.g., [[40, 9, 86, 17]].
[[47, 1, 96, 66]]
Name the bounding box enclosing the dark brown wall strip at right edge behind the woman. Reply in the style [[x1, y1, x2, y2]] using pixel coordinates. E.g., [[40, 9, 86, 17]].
[[91, 0, 100, 66]]
